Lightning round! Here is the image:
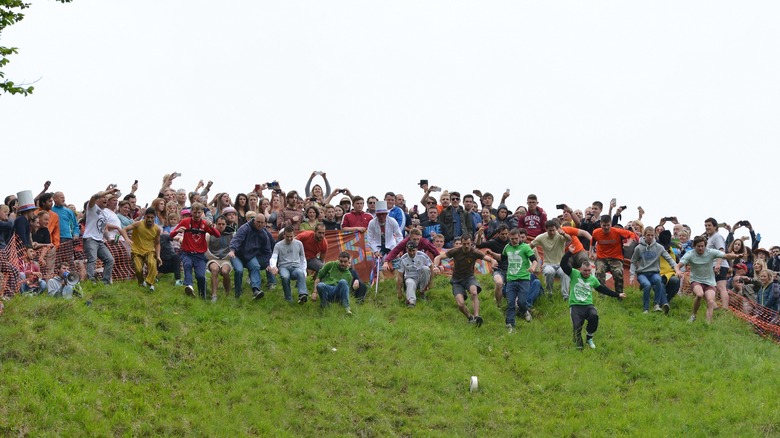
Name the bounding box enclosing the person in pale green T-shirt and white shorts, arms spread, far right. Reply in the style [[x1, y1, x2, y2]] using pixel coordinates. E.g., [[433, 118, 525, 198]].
[[677, 236, 739, 324]]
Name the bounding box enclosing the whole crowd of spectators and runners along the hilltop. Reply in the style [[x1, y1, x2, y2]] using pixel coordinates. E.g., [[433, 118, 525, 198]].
[[0, 172, 780, 348]]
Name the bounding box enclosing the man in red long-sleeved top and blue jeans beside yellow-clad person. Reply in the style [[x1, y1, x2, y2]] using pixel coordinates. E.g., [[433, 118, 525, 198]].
[[171, 202, 219, 298]]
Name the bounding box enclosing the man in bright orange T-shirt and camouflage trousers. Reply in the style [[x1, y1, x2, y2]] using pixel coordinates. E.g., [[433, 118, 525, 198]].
[[590, 215, 634, 294]]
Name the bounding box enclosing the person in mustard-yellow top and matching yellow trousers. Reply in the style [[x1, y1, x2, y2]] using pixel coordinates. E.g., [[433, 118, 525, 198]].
[[124, 207, 162, 292]]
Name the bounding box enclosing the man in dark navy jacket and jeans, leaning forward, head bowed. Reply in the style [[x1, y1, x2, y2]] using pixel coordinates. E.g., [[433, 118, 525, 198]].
[[228, 214, 275, 299]]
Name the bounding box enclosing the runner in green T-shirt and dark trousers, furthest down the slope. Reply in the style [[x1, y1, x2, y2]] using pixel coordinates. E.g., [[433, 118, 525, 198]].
[[561, 245, 626, 350]]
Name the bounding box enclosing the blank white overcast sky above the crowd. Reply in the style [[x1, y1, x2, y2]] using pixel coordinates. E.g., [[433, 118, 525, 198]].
[[0, 0, 780, 247]]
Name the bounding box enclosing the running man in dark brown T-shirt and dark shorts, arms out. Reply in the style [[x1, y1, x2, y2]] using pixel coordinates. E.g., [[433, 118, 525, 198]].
[[433, 234, 498, 327]]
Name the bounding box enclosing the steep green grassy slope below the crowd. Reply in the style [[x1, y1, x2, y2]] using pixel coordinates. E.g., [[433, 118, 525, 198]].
[[0, 278, 780, 437]]
